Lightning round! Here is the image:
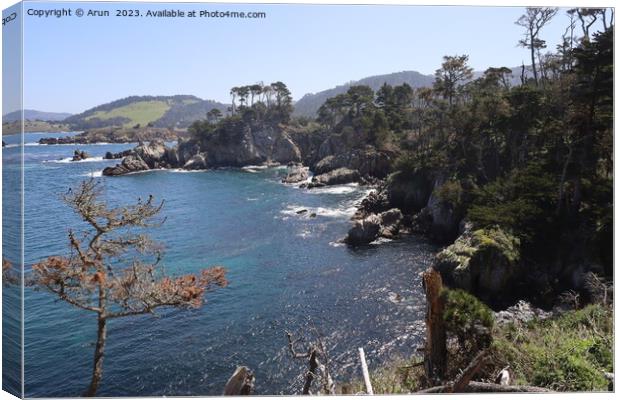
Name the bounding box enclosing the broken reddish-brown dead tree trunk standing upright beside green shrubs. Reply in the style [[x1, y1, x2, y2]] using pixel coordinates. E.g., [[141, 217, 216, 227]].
[[422, 268, 448, 382]]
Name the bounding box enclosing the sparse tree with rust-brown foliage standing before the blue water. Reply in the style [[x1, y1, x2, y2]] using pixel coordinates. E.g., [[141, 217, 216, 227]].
[[29, 180, 227, 396]]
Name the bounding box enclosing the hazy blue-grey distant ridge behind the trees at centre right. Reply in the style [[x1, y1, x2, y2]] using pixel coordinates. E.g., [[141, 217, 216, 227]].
[[293, 66, 531, 118]]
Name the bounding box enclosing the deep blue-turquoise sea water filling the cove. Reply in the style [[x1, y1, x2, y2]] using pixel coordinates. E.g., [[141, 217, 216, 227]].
[[4, 134, 435, 397]]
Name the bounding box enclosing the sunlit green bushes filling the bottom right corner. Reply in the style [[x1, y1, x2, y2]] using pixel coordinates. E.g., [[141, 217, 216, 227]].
[[491, 304, 613, 391]]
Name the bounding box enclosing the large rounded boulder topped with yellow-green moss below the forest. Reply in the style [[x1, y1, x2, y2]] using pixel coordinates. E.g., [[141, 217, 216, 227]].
[[434, 228, 524, 298]]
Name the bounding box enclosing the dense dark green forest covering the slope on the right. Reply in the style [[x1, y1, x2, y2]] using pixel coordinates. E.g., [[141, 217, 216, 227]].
[[388, 13, 614, 273]]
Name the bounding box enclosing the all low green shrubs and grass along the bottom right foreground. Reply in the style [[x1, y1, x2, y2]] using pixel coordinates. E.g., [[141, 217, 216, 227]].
[[346, 304, 613, 394]]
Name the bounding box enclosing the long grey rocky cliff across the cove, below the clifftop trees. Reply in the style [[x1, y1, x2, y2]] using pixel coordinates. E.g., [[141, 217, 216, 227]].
[[104, 121, 394, 183]]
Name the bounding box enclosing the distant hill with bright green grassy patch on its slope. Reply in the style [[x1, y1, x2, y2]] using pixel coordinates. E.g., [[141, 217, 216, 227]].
[[64, 95, 228, 130]]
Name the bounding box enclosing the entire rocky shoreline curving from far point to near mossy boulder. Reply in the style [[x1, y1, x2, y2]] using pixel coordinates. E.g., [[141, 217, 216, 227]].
[[98, 127, 597, 309]]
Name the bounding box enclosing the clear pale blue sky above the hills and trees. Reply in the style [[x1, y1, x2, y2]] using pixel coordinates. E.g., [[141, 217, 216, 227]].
[[4, 3, 608, 113]]
